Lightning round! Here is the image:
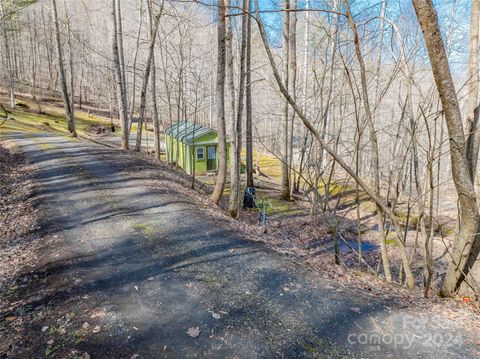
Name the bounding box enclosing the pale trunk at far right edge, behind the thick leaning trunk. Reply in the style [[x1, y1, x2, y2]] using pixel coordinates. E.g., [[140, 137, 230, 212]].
[[467, 0, 480, 183]]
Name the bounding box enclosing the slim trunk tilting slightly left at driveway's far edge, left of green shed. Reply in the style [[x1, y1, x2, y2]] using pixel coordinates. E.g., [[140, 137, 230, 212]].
[[112, 0, 129, 150]]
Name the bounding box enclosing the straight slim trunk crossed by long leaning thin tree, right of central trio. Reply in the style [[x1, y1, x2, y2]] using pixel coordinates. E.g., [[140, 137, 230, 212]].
[[280, 0, 290, 201]]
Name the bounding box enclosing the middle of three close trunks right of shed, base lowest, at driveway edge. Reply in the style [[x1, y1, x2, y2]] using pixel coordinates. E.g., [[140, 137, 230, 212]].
[[228, 0, 250, 218]]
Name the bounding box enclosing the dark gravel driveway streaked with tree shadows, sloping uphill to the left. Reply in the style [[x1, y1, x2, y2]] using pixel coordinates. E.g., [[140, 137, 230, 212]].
[[1, 131, 478, 359]]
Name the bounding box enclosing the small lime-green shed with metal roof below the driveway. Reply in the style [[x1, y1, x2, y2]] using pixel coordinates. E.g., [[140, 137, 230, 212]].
[[165, 121, 230, 175]]
